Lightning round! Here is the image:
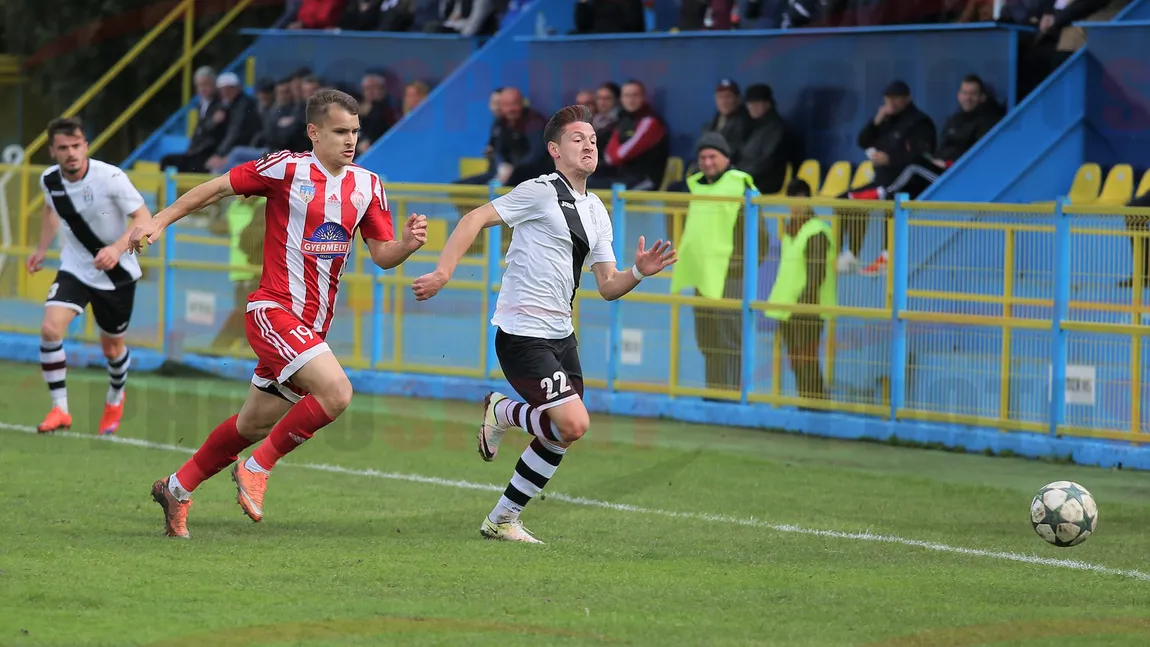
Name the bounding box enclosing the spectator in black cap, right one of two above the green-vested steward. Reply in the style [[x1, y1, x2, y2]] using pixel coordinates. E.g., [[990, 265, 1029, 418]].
[[735, 83, 799, 194]]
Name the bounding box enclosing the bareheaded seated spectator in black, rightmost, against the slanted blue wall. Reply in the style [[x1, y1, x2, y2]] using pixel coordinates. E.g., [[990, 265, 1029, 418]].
[[853, 75, 1004, 200]]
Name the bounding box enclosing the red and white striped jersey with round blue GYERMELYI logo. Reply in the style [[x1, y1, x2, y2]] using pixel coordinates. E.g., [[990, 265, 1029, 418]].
[[229, 151, 394, 334]]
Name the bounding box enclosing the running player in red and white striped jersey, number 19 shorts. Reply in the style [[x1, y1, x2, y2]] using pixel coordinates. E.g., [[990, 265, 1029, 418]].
[[130, 90, 427, 539]]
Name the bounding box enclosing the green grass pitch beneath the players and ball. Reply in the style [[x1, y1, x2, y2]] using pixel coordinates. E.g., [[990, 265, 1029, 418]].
[[0, 364, 1150, 647]]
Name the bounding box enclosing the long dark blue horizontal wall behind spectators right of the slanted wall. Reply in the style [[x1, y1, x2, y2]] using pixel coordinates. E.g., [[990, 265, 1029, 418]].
[[519, 26, 1015, 162]]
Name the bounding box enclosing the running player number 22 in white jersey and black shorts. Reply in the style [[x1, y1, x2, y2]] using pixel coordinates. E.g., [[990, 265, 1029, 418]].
[[412, 106, 676, 544]]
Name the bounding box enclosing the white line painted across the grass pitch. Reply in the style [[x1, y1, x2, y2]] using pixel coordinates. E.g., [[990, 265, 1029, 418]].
[[0, 422, 1150, 581]]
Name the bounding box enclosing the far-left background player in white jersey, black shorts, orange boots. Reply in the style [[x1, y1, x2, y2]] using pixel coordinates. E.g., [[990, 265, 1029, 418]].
[[26, 117, 152, 434]]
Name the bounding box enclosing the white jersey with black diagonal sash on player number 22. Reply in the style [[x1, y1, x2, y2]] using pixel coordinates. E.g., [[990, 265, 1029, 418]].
[[491, 172, 615, 339]]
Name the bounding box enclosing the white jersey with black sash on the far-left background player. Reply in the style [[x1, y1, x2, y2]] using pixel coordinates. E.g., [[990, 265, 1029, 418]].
[[40, 160, 144, 290]]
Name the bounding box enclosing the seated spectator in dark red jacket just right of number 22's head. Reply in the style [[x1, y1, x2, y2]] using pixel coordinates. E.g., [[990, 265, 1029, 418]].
[[589, 79, 670, 191]]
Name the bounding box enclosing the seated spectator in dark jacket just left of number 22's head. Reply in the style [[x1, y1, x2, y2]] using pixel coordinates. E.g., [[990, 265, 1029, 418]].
[[461, 87, 554, 186]]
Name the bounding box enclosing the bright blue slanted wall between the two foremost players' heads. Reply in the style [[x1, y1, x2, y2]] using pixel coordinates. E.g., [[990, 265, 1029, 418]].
[[359, 0, 574, 182]]
